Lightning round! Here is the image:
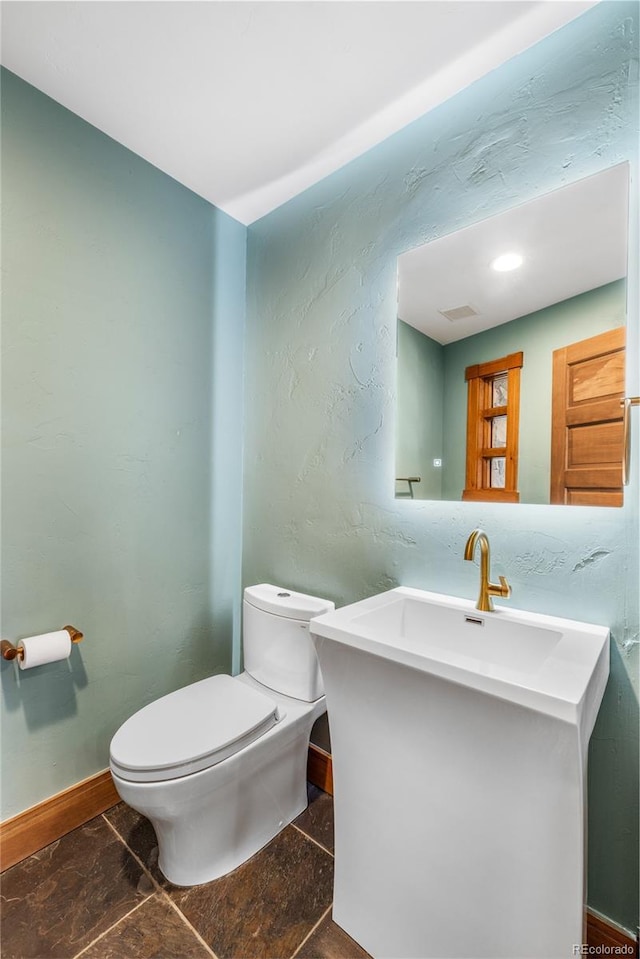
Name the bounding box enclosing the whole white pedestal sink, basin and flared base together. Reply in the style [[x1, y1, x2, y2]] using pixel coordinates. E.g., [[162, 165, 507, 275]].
[[311, 587, 609, 959]]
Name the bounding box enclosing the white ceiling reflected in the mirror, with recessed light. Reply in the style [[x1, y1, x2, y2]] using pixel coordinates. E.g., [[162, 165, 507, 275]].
[[398, 163, 629, 344]]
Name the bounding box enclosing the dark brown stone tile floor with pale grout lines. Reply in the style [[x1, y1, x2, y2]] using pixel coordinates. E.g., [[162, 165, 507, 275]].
[[0, 786, 368, 959]]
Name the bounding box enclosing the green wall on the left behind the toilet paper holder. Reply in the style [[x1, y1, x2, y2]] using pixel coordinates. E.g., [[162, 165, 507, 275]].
[[2, 71, 246, 818]]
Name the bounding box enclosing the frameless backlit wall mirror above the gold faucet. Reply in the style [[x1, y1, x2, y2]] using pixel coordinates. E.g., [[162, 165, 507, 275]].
[[396, 163, 629, 506]]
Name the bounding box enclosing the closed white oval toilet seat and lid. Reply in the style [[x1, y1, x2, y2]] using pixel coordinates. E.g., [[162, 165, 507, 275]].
[[111, 675, 281, 782]]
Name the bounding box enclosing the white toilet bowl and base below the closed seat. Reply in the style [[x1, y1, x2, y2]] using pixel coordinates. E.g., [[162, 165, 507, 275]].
[[112, 674, 325, 886]]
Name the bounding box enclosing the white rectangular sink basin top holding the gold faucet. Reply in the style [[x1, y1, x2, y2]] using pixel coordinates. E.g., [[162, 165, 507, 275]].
[[312, 587, 609, 738]]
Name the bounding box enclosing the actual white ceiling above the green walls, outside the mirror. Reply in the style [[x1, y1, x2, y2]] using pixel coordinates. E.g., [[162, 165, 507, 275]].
[[0, 0, 595, 223]]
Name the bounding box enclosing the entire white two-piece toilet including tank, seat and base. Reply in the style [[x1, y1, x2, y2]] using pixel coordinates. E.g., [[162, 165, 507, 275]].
[[110, 583, 334, 886]]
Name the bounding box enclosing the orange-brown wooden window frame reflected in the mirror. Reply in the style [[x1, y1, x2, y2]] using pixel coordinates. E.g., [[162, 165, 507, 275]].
[[462, 353, 524, 503]]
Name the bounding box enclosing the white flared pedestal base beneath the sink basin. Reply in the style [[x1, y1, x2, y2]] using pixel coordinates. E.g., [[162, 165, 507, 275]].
[[318, 638, 587, 959]]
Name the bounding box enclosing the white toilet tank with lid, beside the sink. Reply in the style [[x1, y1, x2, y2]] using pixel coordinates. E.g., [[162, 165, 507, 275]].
[[242, 583, 335, 703]]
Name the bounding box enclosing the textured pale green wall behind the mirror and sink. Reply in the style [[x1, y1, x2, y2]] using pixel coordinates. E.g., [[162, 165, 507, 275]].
[[243, 3, 638, 928]]
